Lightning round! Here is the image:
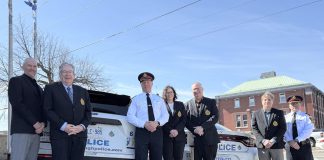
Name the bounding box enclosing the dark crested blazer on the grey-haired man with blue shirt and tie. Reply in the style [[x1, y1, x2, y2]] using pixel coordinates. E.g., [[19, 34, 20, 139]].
[[44, 82, 92, 139]]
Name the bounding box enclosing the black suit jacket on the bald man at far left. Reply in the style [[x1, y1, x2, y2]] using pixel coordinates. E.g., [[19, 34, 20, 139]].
[[8, 74, 46, 134]]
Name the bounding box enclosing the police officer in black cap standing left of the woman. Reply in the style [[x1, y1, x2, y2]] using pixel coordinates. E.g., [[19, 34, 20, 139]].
[[127, 72, 169, 160]]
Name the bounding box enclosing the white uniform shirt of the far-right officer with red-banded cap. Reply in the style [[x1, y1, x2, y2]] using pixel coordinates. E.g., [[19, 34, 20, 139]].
[[284, 111, 314, 142]]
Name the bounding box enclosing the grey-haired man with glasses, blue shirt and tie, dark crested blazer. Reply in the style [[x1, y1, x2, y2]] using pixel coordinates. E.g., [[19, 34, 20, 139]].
[[44, 63, 91, 160]]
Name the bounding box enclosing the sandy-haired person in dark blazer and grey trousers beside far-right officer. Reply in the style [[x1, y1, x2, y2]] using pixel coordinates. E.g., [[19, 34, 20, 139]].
[[252, 91, 287, 160]]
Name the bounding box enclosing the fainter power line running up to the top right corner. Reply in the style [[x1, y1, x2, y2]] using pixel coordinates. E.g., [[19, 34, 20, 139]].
[[135, 0, 323, 54]]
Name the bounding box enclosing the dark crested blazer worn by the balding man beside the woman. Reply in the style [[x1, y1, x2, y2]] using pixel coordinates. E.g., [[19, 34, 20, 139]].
[[186, 97, 220, 145]]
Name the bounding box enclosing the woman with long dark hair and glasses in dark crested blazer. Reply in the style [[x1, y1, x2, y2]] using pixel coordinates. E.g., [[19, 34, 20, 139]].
[[162, 86, 186, 160]]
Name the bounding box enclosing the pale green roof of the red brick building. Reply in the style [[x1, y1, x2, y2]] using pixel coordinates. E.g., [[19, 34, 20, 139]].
[[220, 76, 308, 96]]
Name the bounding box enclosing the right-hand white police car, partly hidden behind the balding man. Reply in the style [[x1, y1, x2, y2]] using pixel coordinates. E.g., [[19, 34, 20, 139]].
[[184, 124, 259, 160]]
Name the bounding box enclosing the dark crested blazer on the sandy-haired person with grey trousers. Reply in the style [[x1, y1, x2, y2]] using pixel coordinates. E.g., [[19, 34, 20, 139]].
[[252, 108, 287, 149]]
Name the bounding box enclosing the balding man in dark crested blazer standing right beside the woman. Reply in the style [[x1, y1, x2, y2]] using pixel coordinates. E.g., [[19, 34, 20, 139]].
[[186, 82, 220, 160]]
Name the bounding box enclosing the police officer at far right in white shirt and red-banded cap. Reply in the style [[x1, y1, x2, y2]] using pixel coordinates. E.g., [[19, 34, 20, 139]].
[[285, 95, 314, 160]]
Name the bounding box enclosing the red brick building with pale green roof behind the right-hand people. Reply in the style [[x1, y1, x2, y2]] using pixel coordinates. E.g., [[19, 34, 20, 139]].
[[216, 72, 324, 132]]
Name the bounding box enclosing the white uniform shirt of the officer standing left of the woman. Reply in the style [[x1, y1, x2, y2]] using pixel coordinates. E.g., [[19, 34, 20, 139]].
[[127, 92, 169, 128]]
